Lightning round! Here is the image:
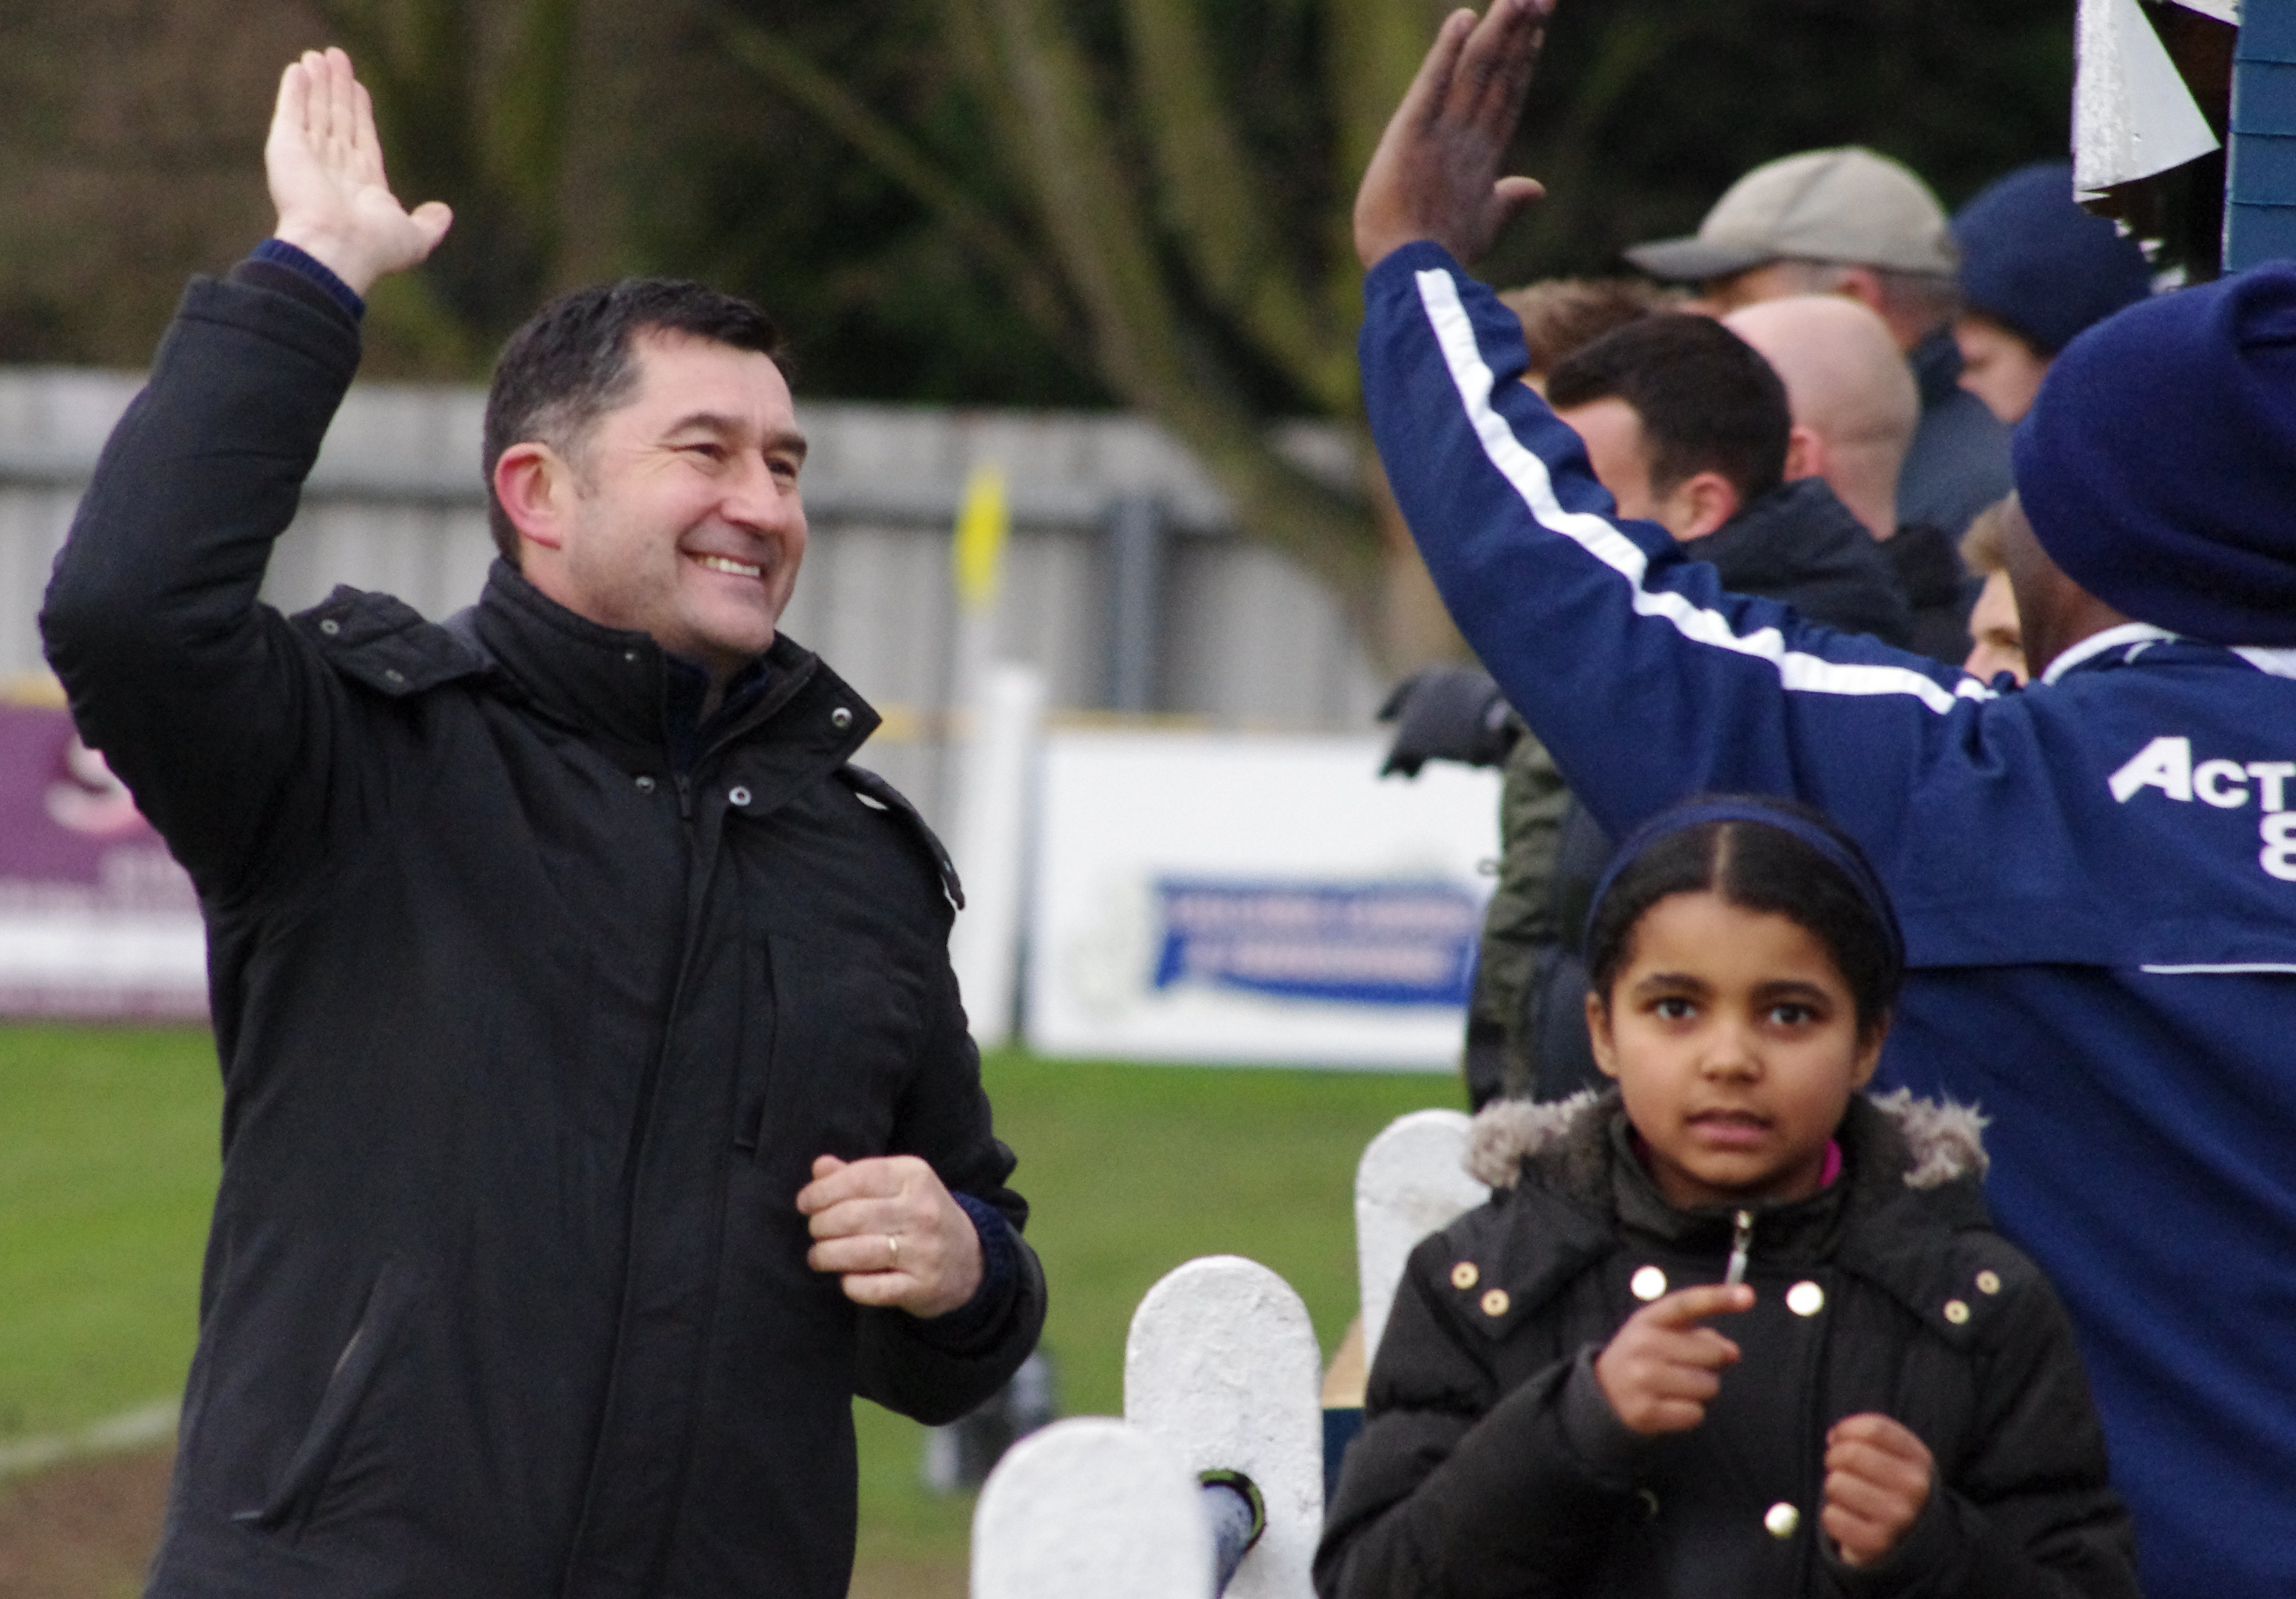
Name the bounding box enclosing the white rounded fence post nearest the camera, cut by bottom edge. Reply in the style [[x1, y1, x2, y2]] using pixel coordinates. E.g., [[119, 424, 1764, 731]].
[[971, 1415, 1213, 1599]]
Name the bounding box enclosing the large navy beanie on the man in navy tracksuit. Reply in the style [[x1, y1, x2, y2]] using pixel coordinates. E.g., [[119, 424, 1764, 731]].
[[2011, 262, 2296, 648]]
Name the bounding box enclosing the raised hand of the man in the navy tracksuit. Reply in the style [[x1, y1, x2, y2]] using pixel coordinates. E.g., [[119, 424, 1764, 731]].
[[1355, 0, 1554, 267]]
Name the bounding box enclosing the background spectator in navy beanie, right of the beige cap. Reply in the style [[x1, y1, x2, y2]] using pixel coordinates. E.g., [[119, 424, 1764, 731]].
[[1954, 161, 2151, 427]]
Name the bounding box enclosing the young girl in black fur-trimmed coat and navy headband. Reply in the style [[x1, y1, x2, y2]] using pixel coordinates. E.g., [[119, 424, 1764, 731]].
[[1315, 800, 2138, 1599]]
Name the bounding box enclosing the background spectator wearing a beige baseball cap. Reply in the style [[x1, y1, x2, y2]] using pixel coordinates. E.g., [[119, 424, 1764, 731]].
[[1626, 145, 2009, 538]]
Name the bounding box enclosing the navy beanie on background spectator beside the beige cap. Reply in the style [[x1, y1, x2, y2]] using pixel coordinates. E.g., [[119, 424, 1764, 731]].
[[1954, 161, 2151, 356]]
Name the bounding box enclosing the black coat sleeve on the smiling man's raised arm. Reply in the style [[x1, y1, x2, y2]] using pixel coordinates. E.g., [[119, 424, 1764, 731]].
[[42, 267, 358, 896]]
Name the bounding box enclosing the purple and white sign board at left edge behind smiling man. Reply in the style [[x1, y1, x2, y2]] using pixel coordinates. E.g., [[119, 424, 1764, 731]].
[[0, 705, 207, 1020]]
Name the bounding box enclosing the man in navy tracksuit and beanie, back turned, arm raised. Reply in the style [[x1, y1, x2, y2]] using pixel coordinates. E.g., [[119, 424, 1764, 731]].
[[1355, 0, 2296, 1599]]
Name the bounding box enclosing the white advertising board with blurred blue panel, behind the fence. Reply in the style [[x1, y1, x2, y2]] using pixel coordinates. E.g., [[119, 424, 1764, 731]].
[[1026, 733, 1499, 1071]]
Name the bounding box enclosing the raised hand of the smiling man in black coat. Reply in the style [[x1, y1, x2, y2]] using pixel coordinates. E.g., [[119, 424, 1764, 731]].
[[264, 48, 455, 294]]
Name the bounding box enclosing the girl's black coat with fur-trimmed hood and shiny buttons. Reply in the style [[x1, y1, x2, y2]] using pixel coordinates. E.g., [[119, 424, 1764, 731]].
[[1315, 1093, 2135, 1599]]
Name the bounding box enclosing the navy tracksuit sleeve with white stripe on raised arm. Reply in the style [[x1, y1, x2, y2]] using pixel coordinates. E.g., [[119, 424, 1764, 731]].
[[1361, 244, 1991, 839]]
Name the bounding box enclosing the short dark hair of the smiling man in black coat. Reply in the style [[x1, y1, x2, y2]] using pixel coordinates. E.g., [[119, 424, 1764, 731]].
[[484, 278, 781, 565]]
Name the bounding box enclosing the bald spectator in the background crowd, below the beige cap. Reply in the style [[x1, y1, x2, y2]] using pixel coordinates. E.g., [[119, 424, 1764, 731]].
[[1722, 294, 1977, 666]]
